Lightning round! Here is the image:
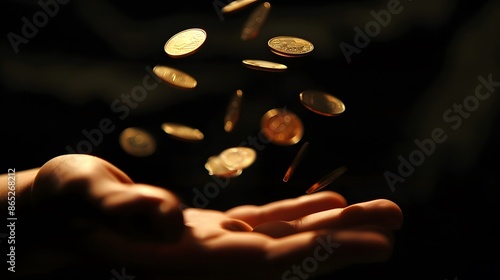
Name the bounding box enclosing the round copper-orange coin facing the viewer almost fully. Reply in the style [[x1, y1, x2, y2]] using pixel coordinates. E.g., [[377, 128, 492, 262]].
[[261, 109, 304, 145]]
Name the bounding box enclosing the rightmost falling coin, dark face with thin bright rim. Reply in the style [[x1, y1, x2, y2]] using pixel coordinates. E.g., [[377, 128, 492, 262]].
[[300, 90, 345, 116]]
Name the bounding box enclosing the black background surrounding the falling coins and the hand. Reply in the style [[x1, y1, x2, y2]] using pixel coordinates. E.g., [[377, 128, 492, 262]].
[[0, 0, 500, 280]]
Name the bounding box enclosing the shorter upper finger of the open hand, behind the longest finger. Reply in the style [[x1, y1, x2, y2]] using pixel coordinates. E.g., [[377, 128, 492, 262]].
[[226, 191, 347, 227]]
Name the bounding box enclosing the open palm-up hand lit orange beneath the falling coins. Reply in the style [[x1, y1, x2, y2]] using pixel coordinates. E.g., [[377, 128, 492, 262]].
[[1, 155, 403, 279]]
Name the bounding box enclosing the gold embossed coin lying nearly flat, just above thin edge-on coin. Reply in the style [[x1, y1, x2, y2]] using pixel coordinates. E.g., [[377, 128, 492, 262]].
[[267, 36, 314, 57]]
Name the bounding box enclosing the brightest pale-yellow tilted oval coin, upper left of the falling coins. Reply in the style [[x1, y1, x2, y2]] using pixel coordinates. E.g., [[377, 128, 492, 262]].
[[164, 28, 207, 57]]
